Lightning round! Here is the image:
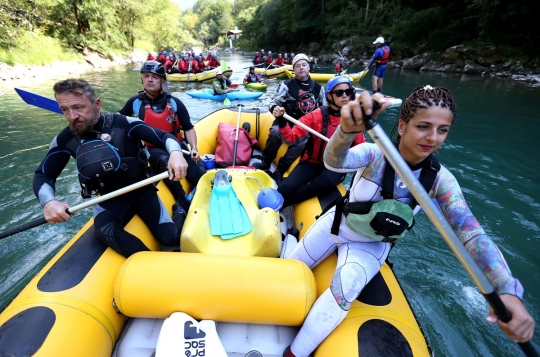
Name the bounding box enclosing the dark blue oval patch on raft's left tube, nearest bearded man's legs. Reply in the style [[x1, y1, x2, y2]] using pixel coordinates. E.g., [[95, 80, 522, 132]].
[[37, 225, 108, 293]]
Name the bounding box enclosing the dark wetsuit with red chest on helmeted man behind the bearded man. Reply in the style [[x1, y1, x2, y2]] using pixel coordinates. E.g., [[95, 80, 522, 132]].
[[119, 92, 203, 206]]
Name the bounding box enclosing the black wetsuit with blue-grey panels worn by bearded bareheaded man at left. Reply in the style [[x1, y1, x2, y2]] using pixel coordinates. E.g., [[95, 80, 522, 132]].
[[33, 114, 183, 257]]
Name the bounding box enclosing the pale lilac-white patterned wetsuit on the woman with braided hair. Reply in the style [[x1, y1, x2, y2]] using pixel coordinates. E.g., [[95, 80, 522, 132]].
[[288, 127, 523, 357]]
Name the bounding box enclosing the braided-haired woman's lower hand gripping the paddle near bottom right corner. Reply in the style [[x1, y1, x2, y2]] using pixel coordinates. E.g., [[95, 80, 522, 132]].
[[486, 294, 535, 342]]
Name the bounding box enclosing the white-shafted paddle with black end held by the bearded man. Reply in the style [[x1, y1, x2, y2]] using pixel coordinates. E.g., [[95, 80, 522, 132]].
[[0, 171, 169, 239]]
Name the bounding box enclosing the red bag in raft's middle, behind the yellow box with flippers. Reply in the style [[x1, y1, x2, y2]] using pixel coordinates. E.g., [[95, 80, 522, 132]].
[[215, 123, 260, 168]]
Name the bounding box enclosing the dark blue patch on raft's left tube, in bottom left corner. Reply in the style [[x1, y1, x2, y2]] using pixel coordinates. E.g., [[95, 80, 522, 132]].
[[0, 306, 56, 356]]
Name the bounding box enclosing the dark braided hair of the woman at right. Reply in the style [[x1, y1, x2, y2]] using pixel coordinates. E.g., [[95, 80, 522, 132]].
[[390, 85, 457, 144]]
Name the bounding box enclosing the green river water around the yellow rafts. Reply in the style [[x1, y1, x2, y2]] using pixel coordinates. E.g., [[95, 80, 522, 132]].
[[0, 54, 540, 357]]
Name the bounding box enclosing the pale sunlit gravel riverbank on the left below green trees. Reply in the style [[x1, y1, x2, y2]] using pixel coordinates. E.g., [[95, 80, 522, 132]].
[[0, 50, 147, 82]]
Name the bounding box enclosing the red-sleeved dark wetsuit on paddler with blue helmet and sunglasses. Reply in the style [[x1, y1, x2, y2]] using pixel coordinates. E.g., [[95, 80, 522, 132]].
[[278, 108, 366, 207]]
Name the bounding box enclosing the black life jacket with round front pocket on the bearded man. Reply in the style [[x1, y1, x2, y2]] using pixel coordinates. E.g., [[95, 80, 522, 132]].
[[66, 113, 149, 198]]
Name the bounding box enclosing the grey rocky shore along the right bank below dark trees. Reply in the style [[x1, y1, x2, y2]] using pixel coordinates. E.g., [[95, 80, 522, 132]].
[[317, 40, 540, 85]]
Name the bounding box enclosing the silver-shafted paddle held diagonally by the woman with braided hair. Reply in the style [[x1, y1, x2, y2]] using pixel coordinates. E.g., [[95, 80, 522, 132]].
[[363, 101, 538, 357]]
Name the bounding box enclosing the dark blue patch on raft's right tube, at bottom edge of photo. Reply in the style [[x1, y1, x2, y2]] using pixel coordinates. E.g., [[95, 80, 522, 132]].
[[358, 319, 413, 357]]
